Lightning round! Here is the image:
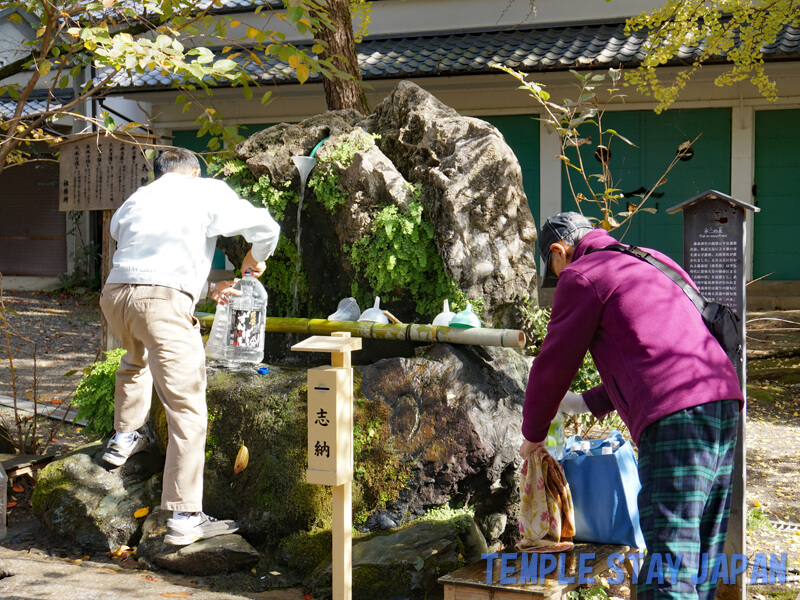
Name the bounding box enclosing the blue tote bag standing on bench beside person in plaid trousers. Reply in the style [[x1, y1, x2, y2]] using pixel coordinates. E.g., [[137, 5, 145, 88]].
[[559, 431, 645, 548]]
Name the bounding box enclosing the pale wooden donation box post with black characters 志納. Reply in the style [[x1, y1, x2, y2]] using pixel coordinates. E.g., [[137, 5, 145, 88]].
[[292, 332, 361, 600]]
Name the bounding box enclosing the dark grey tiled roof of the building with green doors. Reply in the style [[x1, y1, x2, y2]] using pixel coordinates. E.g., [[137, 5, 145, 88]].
[[100, 20, 800, 89]]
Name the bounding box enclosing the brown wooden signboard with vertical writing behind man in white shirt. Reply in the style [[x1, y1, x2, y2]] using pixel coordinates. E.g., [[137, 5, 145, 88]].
[[54, 132, 159, 350]]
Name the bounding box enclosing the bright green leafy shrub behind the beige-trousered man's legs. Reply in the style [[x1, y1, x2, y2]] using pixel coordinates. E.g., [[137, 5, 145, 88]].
[[72, 348, 125, 437]]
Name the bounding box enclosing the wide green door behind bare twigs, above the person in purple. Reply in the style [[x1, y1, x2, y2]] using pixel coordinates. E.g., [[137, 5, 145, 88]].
[[562, 108, 731, 262]]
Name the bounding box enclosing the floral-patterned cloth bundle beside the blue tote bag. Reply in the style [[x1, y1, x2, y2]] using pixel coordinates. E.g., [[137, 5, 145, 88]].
[[517, 446, 575, 552]]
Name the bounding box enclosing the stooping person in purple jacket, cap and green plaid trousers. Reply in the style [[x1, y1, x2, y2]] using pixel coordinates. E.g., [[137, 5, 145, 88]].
[[520, 212, 744, 600]]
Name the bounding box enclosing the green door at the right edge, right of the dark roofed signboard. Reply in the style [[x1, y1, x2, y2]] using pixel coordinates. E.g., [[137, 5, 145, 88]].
[[753, 109, 800, 281]]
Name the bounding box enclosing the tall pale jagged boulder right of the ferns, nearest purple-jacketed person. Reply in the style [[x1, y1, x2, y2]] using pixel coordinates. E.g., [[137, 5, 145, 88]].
[[361, 81, 536, 328]]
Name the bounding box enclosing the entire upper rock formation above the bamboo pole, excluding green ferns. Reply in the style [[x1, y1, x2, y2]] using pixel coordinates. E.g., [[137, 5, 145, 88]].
[[231, 81, 536, 328]]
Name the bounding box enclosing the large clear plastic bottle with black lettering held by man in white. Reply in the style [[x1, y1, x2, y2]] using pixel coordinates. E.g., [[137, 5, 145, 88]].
[[206, 273, 267, 367]]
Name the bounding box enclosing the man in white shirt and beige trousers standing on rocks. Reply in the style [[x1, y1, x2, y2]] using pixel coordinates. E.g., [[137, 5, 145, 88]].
[[100, 148, 280, 545]]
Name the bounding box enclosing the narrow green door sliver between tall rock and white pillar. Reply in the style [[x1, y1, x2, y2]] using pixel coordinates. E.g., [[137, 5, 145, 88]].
[[481, 115, 539, 227]]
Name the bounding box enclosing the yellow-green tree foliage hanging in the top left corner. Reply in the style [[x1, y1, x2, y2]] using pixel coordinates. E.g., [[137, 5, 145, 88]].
[[0, 0, 348, 171]]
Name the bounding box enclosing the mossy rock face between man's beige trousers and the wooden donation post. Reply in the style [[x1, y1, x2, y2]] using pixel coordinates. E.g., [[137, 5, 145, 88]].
[[204, 367, 332, 544]]
